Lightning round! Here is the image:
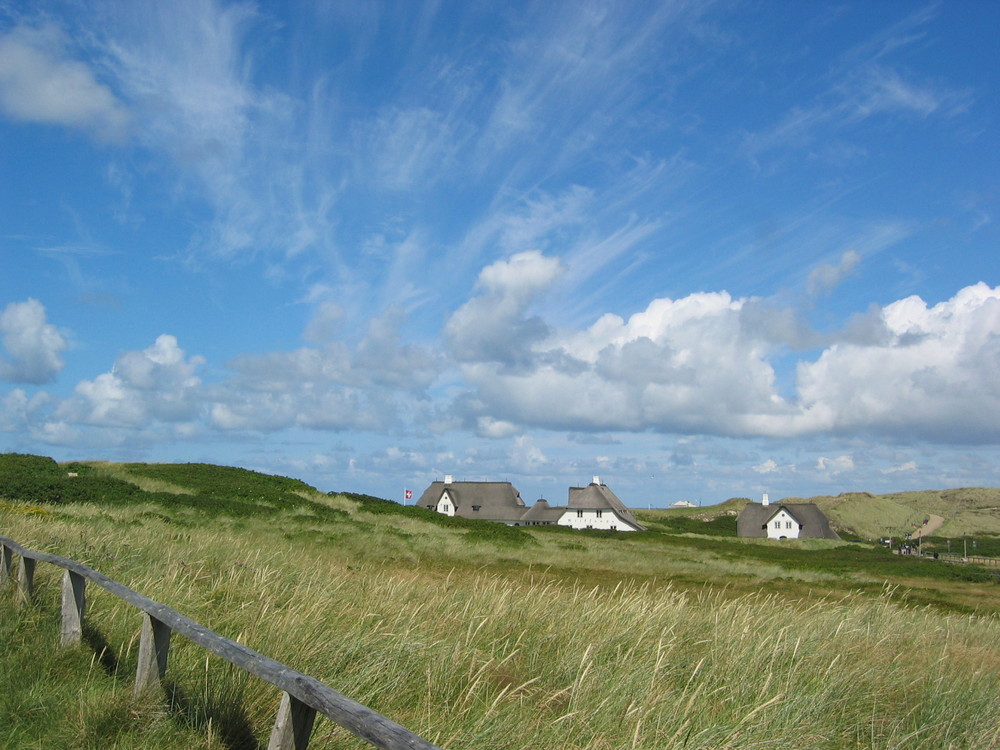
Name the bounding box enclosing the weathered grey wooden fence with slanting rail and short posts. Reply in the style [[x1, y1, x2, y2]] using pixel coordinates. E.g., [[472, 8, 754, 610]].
[[0, 536, 439, 750]]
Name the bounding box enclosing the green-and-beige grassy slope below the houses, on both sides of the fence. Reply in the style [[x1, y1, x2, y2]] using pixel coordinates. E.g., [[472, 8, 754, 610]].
[[0, 456, 1000, 748]]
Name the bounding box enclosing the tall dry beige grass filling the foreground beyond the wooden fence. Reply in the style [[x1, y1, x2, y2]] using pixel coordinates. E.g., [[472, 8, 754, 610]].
[[0, 488, 1000, 750]]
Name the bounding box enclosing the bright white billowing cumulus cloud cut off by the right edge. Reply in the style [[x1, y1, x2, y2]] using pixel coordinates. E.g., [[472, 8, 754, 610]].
[[782, 283, 1000, 442]]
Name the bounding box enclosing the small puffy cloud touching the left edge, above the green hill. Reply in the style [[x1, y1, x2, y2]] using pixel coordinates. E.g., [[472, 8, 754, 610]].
[[0, 299, 67, 384]]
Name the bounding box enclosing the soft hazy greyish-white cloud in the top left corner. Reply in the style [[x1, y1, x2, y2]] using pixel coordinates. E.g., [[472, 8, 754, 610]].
[[0, 27, 129, 140]]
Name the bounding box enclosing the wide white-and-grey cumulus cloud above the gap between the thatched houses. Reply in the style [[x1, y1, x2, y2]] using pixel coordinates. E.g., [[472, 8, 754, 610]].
[[464, 292, 788, 433]]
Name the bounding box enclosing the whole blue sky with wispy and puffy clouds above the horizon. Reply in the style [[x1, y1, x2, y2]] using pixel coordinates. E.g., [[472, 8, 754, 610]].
[[0, 0, 1000, 507]]
